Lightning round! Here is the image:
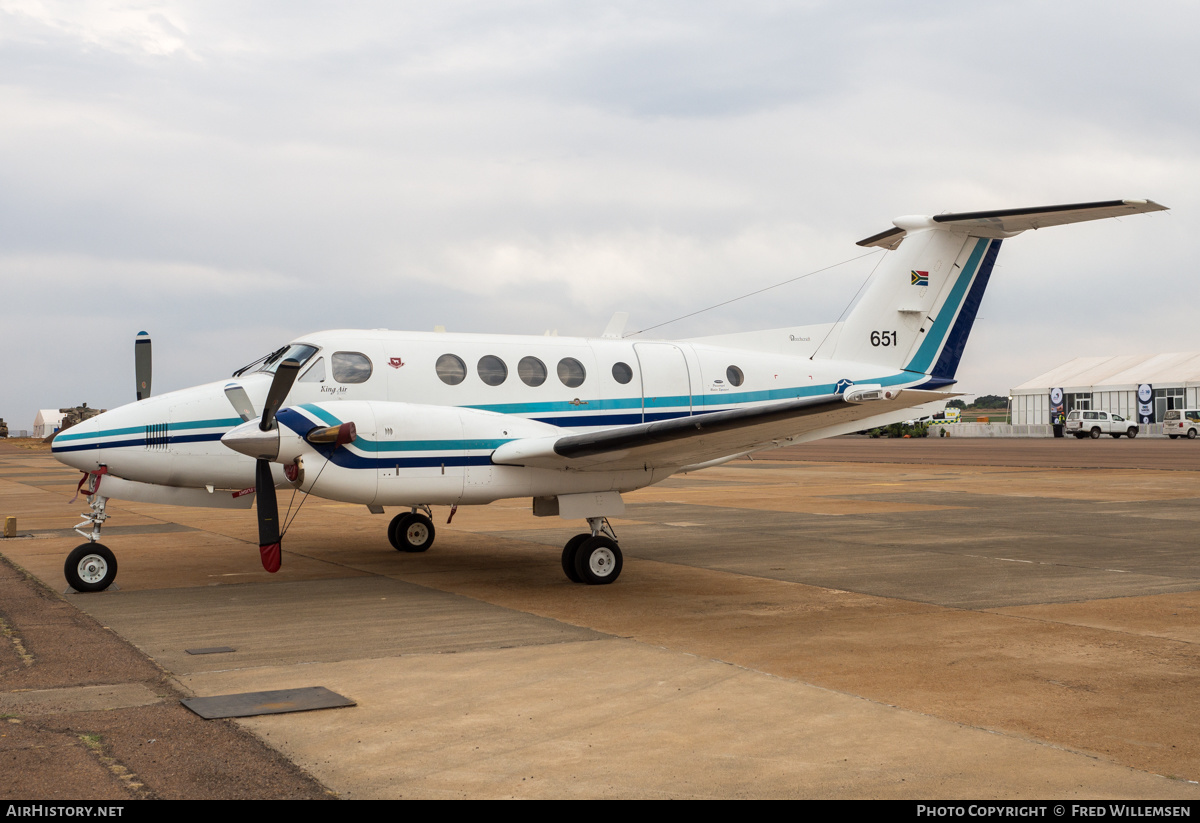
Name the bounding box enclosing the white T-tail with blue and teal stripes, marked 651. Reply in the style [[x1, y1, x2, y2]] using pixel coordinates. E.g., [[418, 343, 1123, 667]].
[[815, 200, 1166, 388]]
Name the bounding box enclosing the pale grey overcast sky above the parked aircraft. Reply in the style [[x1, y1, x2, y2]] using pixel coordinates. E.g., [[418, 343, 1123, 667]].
[[0, 0, 1200, 429]]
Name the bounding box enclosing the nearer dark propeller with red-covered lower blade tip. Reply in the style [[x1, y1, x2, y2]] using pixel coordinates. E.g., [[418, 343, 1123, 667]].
[[222, 359, 300, 573]]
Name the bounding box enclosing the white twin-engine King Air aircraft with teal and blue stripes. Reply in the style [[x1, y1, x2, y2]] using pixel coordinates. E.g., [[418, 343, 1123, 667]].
[[53, 200, 1165, 591]]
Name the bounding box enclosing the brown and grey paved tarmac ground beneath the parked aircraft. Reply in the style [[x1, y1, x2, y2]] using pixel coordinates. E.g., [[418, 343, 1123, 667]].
[[0, 438, 1200, 799]]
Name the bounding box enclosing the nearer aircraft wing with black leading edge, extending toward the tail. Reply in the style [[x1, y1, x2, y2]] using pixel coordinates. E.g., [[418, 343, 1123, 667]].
[[492, 386, 955, 471]]
